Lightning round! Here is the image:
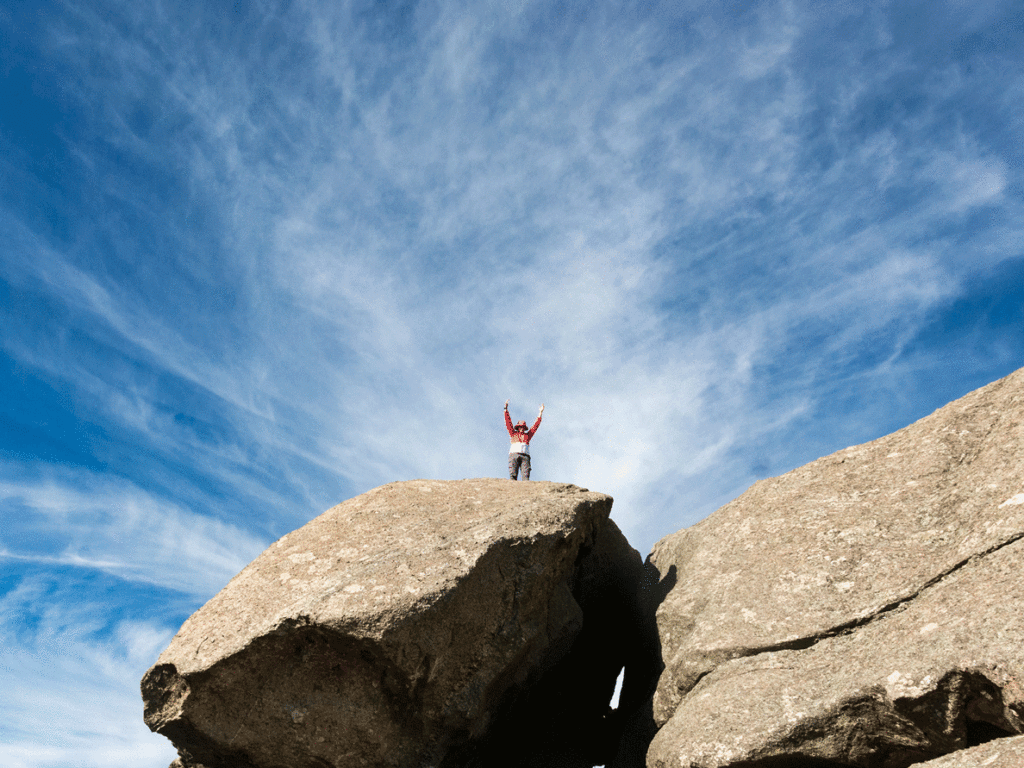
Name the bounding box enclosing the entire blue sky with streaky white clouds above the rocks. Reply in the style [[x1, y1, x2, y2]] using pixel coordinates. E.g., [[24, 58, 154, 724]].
[[0, 0, 1024, 768]]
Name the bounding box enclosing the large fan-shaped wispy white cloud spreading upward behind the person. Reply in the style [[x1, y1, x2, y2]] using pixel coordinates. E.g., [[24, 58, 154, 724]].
[[6, 3, 1016, 548]]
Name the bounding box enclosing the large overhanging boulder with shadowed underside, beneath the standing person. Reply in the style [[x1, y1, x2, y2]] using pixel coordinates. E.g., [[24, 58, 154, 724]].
[[142, 479, 643, 768]]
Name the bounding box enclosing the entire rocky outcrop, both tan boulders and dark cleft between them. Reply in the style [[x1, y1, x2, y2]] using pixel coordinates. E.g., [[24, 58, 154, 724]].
[[142, 370, 1024, 768]]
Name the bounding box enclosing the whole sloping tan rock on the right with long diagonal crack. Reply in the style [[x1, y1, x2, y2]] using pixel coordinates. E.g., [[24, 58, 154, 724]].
[[647, 371, 1024, 768]]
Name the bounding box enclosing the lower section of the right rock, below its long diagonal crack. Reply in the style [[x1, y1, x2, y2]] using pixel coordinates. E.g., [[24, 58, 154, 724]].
[[648, 542, 1024, 768]]
